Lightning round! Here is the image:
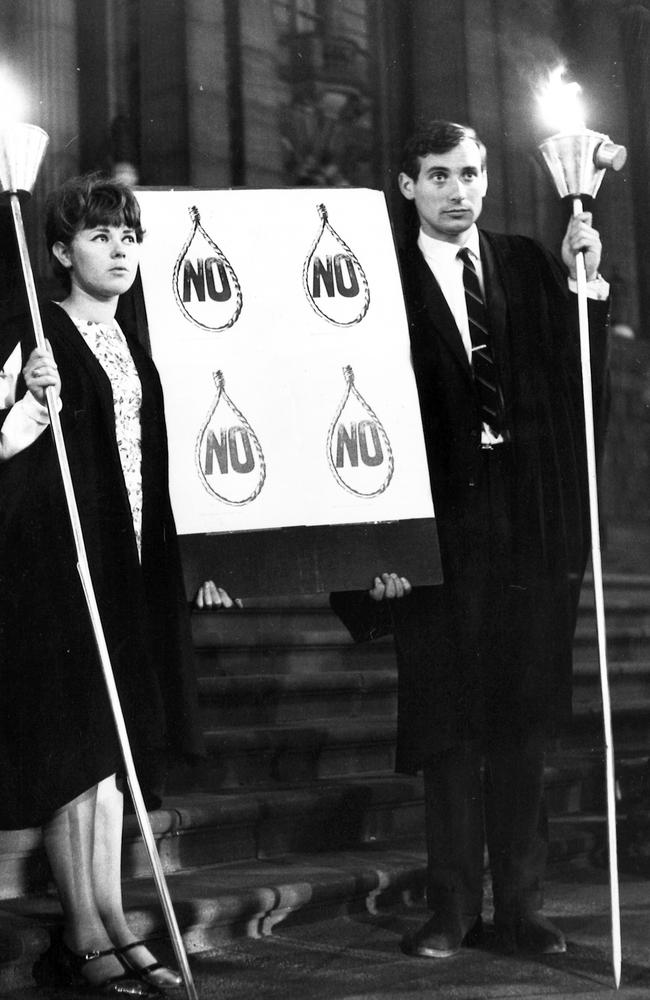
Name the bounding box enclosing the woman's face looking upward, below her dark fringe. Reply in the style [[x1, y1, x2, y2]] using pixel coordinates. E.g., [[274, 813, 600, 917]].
[[53, 225, 140, 301]]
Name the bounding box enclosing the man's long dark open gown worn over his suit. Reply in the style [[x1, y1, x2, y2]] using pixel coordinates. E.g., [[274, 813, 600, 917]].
[[332, 231, 608, 772]]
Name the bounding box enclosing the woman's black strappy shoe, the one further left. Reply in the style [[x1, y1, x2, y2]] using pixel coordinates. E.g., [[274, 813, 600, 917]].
[[32, 937, 162, 998]]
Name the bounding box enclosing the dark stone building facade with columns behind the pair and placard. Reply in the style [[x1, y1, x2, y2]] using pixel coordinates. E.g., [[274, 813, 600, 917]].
[[0, 0, 650, 548]]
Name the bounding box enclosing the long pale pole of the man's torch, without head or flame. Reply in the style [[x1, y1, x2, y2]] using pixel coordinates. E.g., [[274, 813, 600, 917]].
[[573, 191, 621, 989]]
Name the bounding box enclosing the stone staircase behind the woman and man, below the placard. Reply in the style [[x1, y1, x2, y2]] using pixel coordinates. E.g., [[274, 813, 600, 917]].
[[0, 574, 650, 995]]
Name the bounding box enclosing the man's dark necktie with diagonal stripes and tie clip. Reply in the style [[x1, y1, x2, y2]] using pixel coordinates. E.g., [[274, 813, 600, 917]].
[[457, 247, 503, 432]]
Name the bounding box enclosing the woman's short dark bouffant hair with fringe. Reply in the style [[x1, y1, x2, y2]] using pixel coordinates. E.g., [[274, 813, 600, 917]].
[[45, 173, 144, 289]]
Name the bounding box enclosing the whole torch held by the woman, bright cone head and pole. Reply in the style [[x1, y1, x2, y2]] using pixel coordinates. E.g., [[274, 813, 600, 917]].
[[0, 99, 198, 1000]]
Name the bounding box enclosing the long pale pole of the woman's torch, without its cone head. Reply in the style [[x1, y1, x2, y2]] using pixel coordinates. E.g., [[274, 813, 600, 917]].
[[10, 193, 198, 1000]]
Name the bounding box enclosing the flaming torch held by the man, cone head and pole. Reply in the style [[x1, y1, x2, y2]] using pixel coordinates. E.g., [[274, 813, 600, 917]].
[[539, 68, 627, 989]]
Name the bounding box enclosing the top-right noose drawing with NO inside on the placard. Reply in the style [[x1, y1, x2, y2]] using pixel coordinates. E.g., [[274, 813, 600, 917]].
[[302, 204, 370, 326]]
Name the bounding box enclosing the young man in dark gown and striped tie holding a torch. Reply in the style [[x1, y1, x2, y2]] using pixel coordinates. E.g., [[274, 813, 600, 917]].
[[332, 122, 609, 958]]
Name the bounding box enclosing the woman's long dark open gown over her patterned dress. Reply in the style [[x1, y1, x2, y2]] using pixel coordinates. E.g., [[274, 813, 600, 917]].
[[0, 303, 201, 828]]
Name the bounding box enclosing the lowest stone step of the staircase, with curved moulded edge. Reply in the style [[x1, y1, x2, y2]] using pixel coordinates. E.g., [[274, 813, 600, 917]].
[[0, 815, 603, 995]]
